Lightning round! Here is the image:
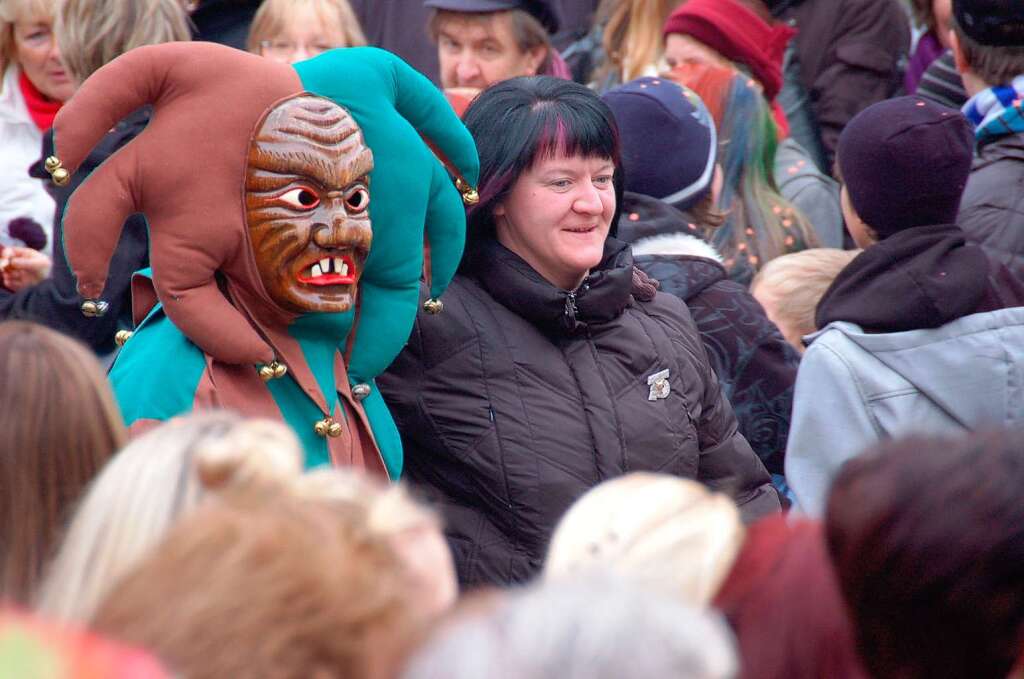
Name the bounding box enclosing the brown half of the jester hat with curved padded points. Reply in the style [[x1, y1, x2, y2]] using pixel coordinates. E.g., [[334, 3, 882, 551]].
[[53, 43, 303, 364]]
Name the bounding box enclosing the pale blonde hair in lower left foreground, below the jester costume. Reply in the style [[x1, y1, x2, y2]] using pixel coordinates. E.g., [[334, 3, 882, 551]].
[[39, 413, 302, 622]]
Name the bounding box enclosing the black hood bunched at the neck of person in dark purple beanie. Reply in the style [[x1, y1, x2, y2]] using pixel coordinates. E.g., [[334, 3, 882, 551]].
[[815, 224, 989, 333]]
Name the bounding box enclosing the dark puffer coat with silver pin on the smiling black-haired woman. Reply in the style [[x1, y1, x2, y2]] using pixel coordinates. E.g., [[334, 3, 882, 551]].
[[379, 239, 779, 585]]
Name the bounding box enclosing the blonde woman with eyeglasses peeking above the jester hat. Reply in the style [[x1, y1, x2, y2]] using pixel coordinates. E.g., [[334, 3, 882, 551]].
[[246, 0, 367, 63]]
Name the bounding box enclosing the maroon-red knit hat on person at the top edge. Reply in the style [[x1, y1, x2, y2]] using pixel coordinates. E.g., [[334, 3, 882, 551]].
[[662, 0, 797, 101]]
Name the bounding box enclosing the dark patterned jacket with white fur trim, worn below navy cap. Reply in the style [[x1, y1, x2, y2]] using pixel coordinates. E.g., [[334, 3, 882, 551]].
[[618, 193, 800, 474]]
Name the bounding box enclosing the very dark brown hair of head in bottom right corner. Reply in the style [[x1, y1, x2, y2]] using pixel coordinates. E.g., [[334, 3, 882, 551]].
[[825, 431, 1024, 679]]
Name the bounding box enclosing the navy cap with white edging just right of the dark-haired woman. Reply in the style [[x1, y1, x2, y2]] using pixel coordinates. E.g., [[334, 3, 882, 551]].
[[601, 78, 717, 210]]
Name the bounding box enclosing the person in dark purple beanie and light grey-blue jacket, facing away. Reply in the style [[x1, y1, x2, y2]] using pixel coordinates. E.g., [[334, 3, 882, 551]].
[[785, 96, 1024, 515]]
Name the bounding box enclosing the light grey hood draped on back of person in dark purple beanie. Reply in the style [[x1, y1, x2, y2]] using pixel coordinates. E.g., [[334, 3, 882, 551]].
[[809, 307, 1024, 429]]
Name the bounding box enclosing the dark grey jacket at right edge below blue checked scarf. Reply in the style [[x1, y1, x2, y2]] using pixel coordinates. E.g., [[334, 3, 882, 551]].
[[956, 134, 1024, 281]]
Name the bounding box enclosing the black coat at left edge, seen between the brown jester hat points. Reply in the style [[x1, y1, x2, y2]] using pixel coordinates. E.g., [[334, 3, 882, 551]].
[[0, 108, 151, 354]]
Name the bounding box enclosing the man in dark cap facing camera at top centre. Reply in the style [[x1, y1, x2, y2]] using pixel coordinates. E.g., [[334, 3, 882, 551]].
[[424, 0, 568, 99]]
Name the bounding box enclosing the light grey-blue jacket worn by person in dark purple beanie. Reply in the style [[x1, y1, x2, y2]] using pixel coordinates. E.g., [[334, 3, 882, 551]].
[[785, 307, 1024, 516]]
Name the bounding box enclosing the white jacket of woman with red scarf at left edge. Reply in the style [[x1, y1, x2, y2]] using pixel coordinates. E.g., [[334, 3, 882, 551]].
[[0, 66, 56, 254]]
